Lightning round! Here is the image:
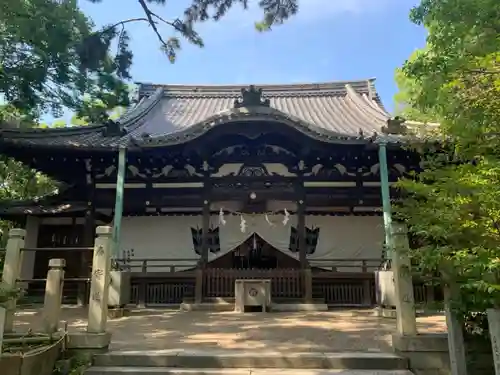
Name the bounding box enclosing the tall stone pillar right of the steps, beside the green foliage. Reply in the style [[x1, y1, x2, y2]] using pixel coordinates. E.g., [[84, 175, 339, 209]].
[[391, 223, 417, 336]]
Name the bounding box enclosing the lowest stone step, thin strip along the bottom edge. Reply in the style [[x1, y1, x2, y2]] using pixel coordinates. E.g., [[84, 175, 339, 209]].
[[85, 367, 413, 375]]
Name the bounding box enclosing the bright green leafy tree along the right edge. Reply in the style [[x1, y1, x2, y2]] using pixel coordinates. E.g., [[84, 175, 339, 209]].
[[399, 0, 500, 334]]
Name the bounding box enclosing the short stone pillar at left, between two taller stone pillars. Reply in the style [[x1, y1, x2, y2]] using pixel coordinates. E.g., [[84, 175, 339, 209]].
[[43, 259, 66, 334]]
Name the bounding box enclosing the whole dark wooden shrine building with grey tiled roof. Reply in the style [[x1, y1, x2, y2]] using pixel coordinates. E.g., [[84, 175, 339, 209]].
[[0, 79, 419, 306]]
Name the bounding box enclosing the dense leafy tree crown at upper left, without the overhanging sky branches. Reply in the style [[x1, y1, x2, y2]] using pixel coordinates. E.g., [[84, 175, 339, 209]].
[[0, 0, 132, 122]]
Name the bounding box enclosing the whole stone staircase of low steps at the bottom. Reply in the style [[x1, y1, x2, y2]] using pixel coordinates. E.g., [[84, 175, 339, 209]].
[[85, 350, 413, 375]]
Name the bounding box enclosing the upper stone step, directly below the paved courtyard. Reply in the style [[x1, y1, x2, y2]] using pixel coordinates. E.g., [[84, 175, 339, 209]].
[[94, 350, 408, 370]]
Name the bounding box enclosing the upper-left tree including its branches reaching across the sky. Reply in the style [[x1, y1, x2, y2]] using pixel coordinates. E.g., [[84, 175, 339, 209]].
[[0, 0, 298, 122]]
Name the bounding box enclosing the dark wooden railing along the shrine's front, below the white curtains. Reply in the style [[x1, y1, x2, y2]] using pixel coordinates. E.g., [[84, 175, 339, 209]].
[[9, 247, 442, 306]]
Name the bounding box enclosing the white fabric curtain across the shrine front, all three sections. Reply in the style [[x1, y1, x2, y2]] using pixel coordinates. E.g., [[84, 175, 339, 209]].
[[121, 214, 384, 272]]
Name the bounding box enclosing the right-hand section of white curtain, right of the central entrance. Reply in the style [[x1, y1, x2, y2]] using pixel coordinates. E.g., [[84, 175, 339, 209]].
[[306, 215, 384, 272]]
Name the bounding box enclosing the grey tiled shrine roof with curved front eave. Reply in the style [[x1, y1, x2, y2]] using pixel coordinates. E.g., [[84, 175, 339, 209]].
[[0, 80, 398, 148]]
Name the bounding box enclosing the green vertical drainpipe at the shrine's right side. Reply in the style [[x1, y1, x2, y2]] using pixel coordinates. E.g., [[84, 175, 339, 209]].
[[378, 141, 393, 267]]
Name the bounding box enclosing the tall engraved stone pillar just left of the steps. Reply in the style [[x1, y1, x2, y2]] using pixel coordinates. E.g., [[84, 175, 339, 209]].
[[87, 226, 113, 333]]
